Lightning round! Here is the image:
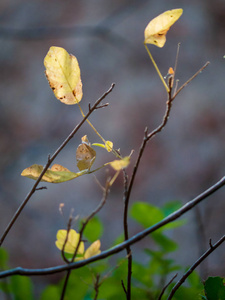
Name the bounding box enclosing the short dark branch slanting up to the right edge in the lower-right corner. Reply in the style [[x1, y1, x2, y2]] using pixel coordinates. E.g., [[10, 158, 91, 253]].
[[167, 235, 225, 300]]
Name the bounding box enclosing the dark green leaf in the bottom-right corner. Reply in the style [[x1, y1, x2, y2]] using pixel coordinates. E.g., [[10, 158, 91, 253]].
[[204, 276, 225, 300]]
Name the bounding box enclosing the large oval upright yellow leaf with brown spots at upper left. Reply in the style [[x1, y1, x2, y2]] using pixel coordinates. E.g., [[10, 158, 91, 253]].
[[44, 47, 83, 105]]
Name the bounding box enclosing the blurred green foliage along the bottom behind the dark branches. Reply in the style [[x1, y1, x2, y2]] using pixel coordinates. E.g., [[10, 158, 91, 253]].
[[0, 202, 225, 300]]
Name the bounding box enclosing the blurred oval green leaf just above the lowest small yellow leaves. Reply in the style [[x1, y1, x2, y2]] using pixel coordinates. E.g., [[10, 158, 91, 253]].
[[84, 216, 103, 243]]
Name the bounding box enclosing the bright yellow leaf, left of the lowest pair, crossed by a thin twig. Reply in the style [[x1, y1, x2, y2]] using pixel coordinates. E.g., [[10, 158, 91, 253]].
[[55, 229, 84, 255]]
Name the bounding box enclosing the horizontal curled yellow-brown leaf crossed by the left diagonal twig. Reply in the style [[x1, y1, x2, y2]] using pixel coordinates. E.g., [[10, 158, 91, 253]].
[[21, 164, 87, 183]]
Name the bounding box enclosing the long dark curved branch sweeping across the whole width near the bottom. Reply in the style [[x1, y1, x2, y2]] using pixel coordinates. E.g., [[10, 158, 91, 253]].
[[0, 176, 225, 278]]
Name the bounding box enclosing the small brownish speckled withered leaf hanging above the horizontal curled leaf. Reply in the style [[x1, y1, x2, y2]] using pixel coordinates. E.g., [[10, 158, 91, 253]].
[[76, 135, 96, 171]]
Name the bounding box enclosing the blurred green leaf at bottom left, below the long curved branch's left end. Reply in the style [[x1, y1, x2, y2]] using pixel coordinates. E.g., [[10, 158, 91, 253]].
[[11, 276, 33, 300]]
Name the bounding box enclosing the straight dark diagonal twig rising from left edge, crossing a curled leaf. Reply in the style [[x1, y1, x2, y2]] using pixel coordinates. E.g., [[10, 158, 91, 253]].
[[0, 83, 115, 247]]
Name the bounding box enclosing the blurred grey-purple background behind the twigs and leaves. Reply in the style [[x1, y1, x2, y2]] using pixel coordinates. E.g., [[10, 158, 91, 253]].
[[0, 0, 225, 296]]
